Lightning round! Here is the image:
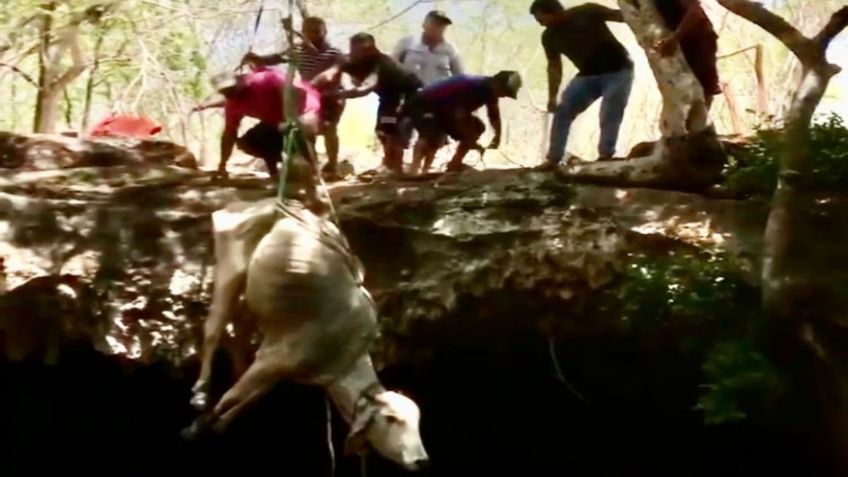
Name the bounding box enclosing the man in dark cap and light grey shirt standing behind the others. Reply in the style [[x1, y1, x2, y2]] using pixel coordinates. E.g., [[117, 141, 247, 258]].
[[392, 10, 465, 85]]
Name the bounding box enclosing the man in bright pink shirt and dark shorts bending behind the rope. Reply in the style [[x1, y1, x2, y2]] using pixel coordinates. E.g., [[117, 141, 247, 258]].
[[193, 67, 321, 178]]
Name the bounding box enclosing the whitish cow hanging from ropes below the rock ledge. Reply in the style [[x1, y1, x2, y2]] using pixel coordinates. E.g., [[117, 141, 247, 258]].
[[185, 195, 429, 471]]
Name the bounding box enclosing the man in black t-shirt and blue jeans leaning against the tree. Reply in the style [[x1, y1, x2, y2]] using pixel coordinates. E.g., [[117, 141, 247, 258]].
[[530, 0, 633, 167]]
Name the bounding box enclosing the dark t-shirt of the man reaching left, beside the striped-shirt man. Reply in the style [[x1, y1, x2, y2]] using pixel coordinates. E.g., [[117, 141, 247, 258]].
[[341, 53, 424, 99]]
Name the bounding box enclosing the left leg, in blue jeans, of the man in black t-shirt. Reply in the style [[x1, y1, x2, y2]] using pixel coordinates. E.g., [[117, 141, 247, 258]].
[[548, 76, 602, 164]]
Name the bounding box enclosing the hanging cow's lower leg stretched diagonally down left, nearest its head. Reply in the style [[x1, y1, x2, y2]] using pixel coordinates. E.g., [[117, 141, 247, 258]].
[[213, 339, 292, 431]]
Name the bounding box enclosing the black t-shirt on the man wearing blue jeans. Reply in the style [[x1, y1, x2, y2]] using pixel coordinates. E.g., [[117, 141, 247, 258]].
[[542, 3, 633, 76]]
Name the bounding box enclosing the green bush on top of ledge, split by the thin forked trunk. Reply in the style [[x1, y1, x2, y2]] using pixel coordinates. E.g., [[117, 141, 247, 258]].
[[725, 114, 848, 194]]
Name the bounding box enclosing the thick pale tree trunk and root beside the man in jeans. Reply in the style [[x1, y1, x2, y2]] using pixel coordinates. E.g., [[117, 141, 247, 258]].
[[569, 0, 726, 190]]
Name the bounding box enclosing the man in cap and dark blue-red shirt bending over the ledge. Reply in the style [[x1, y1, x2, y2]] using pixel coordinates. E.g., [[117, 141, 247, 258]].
[[408, 71, 521, 174]]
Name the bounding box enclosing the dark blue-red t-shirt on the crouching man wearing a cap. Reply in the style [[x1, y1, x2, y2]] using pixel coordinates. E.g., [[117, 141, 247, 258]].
[[419, 75, 498, 112]]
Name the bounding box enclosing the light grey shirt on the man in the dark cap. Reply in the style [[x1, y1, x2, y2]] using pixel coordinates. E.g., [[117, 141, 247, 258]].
[[392, 35, 465, 85]]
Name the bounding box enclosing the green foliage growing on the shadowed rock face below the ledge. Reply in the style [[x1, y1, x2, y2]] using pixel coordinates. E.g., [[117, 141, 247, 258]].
[[616, 254, 777, 425]]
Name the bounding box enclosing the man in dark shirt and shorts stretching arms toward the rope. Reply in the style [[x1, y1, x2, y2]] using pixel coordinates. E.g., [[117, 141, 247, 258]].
[[313, 33, 423, 173]]
